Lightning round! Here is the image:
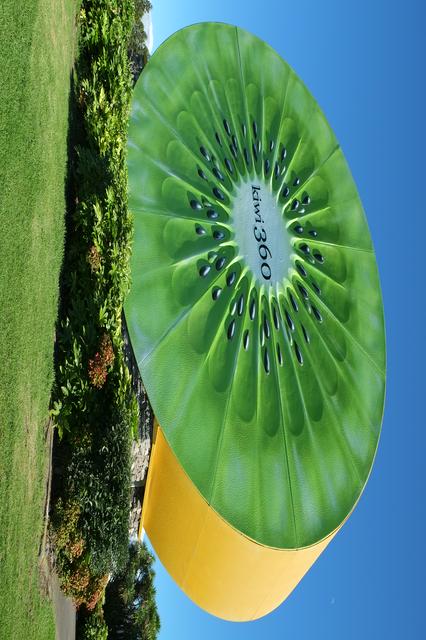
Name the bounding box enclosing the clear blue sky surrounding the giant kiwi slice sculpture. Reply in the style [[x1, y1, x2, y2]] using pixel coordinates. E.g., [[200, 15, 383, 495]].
[[144, 0, 426, 640]]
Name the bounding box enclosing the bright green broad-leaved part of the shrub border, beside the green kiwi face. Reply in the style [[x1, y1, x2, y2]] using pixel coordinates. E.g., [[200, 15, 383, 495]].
[[52, 0, 133, 433]]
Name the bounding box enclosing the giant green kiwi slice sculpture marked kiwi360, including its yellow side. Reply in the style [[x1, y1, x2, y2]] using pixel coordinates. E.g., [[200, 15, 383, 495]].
[[126, 23, 385, 620]]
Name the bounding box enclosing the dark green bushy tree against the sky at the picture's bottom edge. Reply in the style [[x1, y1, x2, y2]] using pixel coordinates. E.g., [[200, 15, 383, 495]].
[[104, 543, 160, 640]]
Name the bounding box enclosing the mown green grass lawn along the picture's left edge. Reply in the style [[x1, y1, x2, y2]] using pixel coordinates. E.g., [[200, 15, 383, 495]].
[[0, 0, 77, 640]]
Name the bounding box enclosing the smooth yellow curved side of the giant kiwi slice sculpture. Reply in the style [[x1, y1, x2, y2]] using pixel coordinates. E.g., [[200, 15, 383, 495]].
[[141, 425, 340, 621]]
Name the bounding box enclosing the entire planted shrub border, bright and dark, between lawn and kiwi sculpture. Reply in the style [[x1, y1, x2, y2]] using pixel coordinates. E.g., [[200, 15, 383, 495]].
[[51, 0, 144, 608]]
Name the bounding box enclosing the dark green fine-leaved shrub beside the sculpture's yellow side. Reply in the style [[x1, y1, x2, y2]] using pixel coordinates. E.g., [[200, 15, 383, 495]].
[[62, 372, 132, 574]]
